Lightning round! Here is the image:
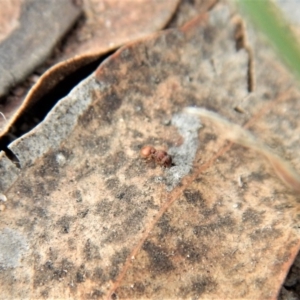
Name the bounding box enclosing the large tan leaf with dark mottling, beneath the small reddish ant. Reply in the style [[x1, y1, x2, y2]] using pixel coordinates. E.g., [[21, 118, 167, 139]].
[[0, 5, 300, 299]]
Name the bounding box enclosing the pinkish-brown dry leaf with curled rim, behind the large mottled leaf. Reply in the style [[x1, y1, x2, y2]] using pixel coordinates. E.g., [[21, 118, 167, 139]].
[[0, 0, 179, 135]]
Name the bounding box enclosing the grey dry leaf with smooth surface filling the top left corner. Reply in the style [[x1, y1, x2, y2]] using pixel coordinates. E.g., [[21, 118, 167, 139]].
[[0, 0, 80, 97]]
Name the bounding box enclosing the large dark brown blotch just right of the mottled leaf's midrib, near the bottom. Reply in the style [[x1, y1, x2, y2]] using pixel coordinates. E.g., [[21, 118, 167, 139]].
[[143, 241, 174, 273]]
